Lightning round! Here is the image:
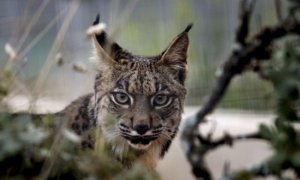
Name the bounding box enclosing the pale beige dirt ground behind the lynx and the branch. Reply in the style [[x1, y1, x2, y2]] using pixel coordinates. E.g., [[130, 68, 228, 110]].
[[4, 96, 273, 180]]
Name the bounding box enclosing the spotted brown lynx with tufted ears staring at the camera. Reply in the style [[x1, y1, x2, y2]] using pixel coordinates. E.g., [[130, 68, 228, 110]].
[[57, 16, 192, 167]]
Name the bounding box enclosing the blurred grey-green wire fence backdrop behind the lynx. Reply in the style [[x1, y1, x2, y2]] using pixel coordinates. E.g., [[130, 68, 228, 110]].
[[0, 0, 285, 110]]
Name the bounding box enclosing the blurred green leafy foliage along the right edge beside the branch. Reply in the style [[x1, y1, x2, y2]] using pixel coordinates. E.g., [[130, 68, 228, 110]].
[[260, 39, 300, 177]]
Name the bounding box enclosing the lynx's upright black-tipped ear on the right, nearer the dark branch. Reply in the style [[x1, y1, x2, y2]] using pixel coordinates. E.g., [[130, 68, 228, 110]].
[[156, 24, 192, 84]]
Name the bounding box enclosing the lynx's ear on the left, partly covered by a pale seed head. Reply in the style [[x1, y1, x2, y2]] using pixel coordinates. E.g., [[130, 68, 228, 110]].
[[91, 14, 127, 65]]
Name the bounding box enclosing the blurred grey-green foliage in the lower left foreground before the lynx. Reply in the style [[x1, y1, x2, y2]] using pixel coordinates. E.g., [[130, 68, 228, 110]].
[[0, 107, 159, 180]]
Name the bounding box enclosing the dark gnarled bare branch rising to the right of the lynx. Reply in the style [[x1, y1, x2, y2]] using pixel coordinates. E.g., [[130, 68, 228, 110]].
[[181, 0, 300, 179]]
